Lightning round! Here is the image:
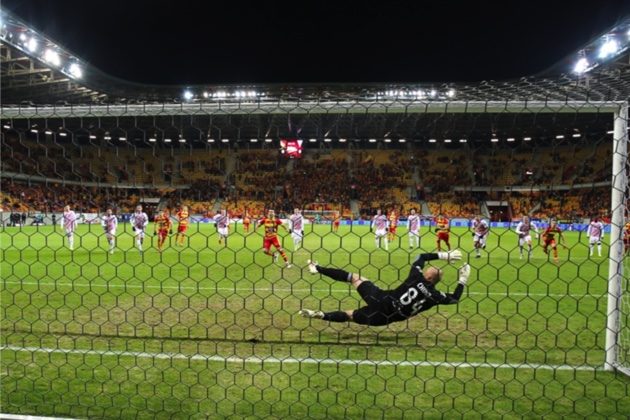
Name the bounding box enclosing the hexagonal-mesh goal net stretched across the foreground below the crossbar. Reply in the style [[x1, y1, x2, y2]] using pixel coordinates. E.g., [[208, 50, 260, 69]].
[[0, 99, 630, 418]]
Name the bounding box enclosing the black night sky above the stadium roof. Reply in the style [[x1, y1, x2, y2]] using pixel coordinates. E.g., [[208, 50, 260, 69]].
[[1, 0, 630, 85]]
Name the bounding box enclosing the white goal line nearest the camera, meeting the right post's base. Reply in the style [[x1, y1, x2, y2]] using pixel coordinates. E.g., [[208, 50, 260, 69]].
[[0, 346, 604, 372]]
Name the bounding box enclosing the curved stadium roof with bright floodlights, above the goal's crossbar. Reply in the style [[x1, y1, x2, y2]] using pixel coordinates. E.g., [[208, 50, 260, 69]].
[[0, 11, 630, 107]]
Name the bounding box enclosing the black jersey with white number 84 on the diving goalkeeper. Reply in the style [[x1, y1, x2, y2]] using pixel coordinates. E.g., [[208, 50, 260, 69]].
[[389, 254, 464, 318]]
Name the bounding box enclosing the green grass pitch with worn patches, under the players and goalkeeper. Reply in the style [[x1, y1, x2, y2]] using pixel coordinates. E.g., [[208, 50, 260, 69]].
[[0, 225, 630, 419]]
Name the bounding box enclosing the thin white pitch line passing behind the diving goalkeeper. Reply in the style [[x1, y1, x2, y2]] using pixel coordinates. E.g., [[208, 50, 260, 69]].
[[2, 280, 607, 299]]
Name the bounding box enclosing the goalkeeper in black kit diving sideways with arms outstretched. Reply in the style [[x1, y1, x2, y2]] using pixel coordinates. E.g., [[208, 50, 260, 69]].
[[300, 250, 470, 326]]
